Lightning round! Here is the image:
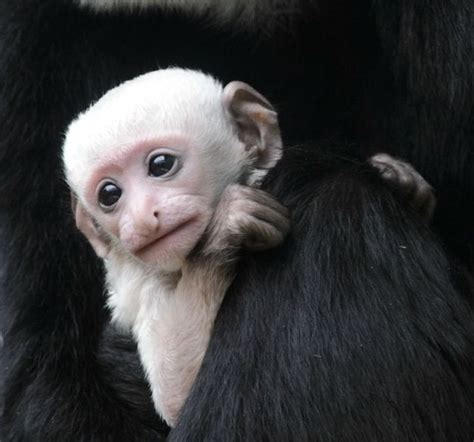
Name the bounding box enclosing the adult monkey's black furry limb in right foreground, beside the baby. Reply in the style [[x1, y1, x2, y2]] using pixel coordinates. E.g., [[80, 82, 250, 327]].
[[170, 147, 474, 442]]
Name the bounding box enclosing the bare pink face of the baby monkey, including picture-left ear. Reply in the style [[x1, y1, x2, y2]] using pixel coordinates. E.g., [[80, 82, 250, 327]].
[[76, 136, 223, 271]]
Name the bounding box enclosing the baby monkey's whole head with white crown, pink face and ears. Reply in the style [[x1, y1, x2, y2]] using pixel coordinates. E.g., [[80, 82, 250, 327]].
[[63, 69, 281, 271]]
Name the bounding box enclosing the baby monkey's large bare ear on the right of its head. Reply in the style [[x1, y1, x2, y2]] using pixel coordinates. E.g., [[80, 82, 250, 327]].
[[223, 81, 282, 169]]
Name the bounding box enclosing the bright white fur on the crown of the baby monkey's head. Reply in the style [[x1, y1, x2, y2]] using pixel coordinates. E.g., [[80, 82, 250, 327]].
[[63, 68, 240, 198]]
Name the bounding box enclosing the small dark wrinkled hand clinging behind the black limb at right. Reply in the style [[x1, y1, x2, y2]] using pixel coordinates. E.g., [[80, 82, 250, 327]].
[[369, 153, 436, 222]]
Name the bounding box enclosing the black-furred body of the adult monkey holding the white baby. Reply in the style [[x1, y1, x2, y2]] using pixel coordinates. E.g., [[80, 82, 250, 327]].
[[0, 0, 474, 441]]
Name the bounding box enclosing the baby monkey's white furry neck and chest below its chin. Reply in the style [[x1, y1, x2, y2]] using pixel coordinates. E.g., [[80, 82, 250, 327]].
[[106, 251, 231, 426]]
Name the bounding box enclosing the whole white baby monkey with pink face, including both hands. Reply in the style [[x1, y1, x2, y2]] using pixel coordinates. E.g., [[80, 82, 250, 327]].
[[63, 69, 431, 426]]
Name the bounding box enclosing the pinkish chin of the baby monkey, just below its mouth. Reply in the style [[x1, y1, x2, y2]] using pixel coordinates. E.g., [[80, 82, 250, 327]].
[[133, 218, 207, 273]]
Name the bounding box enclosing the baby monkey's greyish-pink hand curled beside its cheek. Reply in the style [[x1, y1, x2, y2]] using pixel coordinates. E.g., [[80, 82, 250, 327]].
[[203, 184, 290, 253]]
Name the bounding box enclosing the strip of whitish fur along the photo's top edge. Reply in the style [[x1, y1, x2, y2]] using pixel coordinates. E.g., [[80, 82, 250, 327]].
[[79, 0, 300, 26]]
